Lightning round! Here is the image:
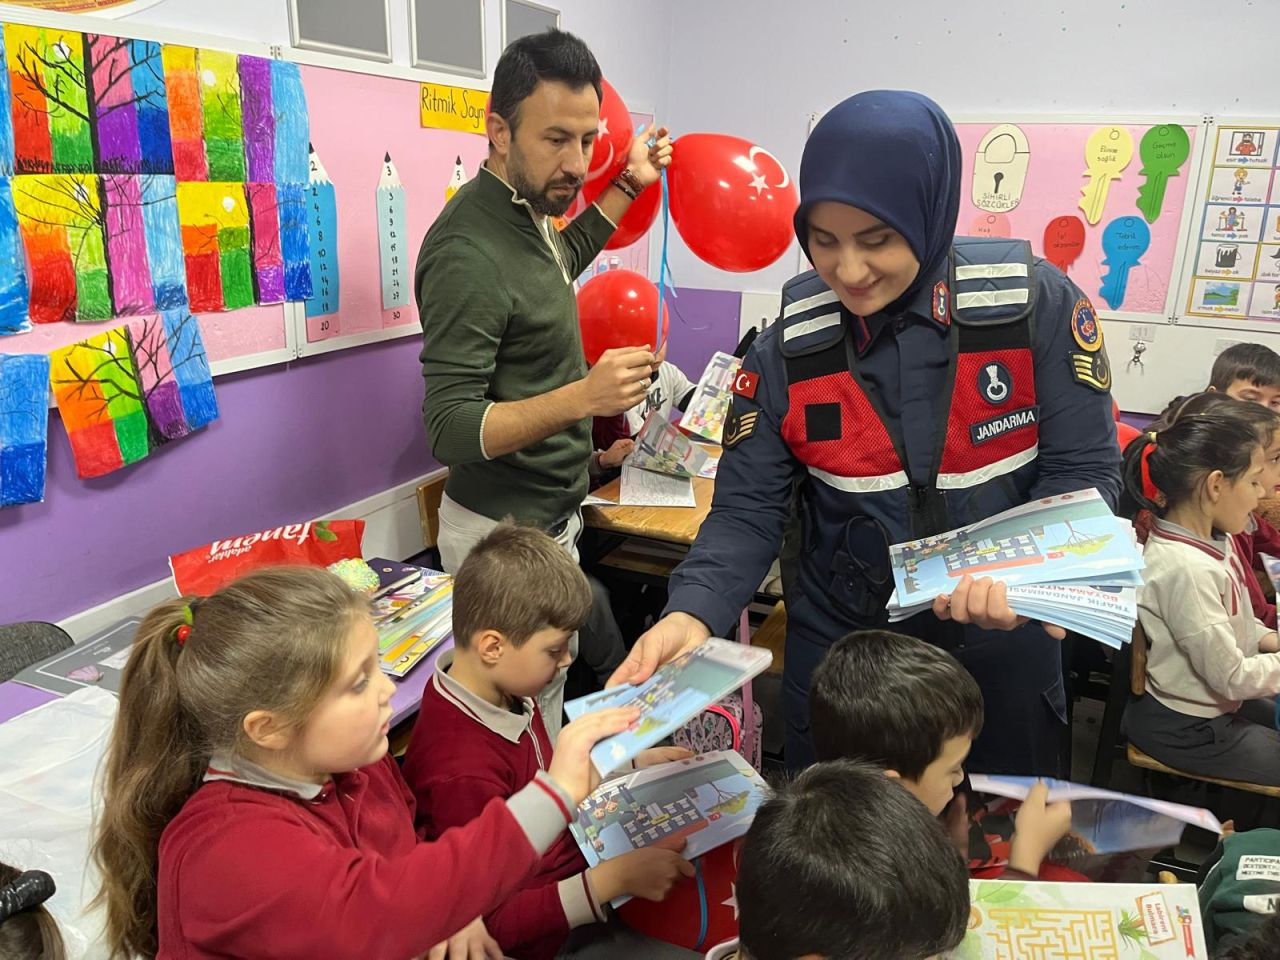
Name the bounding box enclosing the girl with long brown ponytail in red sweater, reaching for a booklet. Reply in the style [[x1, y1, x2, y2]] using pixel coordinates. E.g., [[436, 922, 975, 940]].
[[95, 567, 637, 960]]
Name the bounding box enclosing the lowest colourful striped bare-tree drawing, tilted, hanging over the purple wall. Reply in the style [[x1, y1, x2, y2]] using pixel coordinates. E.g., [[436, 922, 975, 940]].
[[49, 308, 218, 477]]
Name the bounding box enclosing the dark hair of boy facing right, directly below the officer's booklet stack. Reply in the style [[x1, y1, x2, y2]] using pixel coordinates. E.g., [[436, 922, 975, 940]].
[[809, 630, 983, 780]]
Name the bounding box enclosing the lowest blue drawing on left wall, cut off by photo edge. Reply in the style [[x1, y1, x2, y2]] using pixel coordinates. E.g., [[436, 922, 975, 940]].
[[0, 353, 49, 507]]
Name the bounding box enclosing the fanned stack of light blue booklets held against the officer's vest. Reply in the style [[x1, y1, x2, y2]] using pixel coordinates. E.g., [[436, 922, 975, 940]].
[[888, 488, 1143, 649]]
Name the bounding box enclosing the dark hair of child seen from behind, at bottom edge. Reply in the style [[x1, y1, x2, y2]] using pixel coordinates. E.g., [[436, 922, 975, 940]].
[[737, 760, 969, 960]]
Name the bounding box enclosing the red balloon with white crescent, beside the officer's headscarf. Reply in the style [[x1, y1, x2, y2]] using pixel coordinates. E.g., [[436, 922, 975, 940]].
[[667, 133, 800, 273]]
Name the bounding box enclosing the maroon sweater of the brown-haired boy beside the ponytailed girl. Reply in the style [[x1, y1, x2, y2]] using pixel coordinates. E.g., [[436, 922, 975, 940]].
[[404, 655, 604, 960]]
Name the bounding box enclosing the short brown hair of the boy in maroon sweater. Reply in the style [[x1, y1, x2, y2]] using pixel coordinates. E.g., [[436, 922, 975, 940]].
[[453, 522, 591, 649]]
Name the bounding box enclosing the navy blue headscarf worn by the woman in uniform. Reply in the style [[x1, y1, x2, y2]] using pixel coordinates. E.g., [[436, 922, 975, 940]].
[[795, 90, 960, 300]]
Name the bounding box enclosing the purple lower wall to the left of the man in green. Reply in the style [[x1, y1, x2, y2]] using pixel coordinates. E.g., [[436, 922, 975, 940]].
[[0, 338, 435, 622]]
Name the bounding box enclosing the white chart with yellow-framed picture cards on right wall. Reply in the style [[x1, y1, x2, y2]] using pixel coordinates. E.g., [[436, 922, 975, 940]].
[[1185, 124, 1280, 320]]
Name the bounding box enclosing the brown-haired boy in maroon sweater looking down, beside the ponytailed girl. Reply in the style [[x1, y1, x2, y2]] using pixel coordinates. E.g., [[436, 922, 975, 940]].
[[404, 524, 694, 960]]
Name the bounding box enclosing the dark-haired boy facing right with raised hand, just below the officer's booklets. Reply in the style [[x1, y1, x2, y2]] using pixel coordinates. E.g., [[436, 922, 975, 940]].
[[809, 630, 1071, 879]]
